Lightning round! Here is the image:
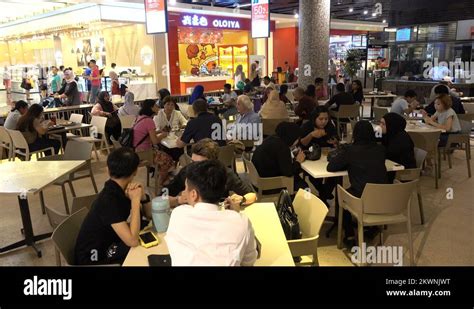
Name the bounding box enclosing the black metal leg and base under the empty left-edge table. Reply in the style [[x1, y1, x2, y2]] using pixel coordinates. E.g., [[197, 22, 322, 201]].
[[0, 196, 51, 257]]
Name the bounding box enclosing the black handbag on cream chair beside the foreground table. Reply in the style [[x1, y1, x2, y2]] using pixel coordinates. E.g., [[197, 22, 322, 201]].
[[277, 189, 301, 240]]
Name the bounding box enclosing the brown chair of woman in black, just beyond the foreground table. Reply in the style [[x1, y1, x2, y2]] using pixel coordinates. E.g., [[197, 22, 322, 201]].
[[242, 157, 294, 202]]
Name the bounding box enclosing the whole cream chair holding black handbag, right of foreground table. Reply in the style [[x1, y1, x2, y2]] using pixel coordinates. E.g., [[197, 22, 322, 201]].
[[288, 189, 328, 266]]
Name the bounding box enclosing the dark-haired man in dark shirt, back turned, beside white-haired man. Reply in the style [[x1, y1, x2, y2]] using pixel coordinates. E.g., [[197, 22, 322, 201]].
[[176, 99, 226, 148]]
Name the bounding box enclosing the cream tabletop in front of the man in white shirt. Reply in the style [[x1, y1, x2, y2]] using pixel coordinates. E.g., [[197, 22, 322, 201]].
[[123, 203, 295, 266]]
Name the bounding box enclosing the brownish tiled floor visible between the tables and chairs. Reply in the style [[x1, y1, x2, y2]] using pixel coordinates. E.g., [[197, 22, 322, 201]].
[[0, 144, 474, 266]]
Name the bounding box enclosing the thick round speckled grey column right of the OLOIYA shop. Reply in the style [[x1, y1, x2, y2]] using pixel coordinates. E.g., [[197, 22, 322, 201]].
[[298, 0, 331, 88]]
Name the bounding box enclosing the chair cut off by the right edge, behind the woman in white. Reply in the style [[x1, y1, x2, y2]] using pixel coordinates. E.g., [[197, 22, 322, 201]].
[[439, 120, 473, 178]]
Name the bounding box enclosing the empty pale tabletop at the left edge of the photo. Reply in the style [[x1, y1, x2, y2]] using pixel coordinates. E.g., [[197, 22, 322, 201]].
[[0, 161, 86, 194]]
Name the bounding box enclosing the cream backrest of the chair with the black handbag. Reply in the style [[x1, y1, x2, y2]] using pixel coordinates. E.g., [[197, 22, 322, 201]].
[[293, 189, 328, 238]]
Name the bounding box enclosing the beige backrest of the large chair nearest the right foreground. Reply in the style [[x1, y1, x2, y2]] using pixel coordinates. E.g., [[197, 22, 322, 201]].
[[361, 180, 418, 214]]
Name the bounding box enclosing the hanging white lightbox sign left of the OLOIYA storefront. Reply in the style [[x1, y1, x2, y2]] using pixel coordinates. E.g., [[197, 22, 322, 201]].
[[145, 0, 168, 34]]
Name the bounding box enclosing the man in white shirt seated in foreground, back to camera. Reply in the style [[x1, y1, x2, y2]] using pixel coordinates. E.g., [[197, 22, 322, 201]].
[[166, 160, 257, 266]]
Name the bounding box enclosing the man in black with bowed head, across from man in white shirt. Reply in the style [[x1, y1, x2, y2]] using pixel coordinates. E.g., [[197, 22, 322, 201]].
[[166, 138, 257, 207]]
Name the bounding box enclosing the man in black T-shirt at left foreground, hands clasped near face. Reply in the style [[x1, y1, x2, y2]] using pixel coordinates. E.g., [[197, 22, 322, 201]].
[[75, 148, 151, 265]]
